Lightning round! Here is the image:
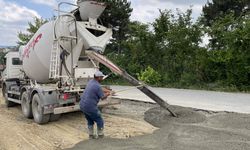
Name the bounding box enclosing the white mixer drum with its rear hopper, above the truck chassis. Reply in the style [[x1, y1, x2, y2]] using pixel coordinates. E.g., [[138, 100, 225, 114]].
[[19, 1, 112, 83]]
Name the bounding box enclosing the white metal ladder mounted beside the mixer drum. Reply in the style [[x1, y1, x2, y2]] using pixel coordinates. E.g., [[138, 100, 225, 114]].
[[49, 40, 60, 79]]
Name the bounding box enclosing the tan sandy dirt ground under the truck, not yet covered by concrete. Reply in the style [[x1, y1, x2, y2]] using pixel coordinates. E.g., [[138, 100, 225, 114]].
[[0, 93, 156, 150]]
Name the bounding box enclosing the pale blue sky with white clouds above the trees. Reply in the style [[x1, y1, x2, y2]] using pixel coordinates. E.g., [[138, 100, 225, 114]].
[[0, 0, 208, 46]]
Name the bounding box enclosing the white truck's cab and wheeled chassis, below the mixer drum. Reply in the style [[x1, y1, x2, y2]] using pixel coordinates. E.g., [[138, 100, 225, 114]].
[[2, 51, 80, 124]]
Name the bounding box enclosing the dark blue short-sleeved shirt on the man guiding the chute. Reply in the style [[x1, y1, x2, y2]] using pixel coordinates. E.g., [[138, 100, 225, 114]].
[[80, 79, 104, 112]]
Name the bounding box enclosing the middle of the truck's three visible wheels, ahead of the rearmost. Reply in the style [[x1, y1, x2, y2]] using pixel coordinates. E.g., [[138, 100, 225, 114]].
[[21, 91, 33, 119]]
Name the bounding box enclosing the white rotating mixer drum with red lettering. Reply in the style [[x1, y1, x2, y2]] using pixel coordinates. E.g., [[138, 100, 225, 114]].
[[20, 18, 73, 83]]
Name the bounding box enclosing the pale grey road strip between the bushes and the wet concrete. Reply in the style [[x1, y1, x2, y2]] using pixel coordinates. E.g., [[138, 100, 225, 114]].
[[111, 86, 250, 113]]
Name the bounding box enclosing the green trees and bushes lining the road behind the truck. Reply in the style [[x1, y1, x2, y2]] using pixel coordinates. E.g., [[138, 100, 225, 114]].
[[15, 0, 250, 92]]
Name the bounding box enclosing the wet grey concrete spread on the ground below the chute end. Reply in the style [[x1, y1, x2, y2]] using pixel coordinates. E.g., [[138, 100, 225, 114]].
[[69, 106, 250, 150]]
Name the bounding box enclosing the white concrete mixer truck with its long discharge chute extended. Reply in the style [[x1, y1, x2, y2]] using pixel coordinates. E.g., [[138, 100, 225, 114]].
[[2, 0, 175, 124]]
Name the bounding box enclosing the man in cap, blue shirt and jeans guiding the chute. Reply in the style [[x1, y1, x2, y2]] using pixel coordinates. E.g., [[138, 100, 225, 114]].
[[80, 71, 112, 139]]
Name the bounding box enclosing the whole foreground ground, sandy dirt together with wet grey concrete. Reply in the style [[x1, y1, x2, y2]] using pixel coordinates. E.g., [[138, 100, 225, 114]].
[[0, 90, 250, 150]]
